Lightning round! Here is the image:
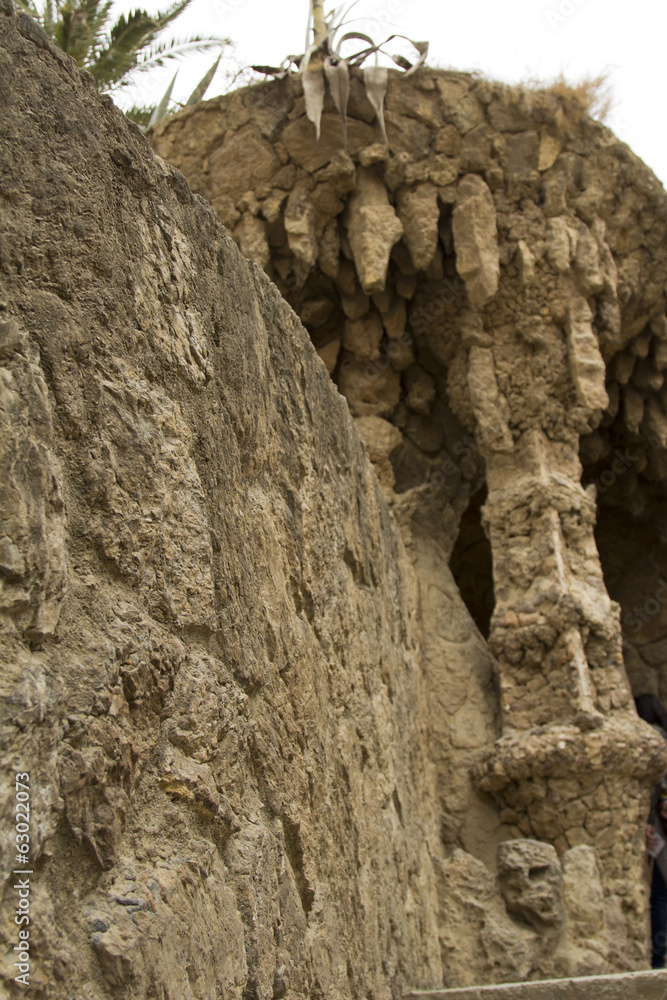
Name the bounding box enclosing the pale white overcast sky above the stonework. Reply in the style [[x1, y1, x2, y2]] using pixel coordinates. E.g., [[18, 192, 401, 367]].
[[114, 0, 667, 186]]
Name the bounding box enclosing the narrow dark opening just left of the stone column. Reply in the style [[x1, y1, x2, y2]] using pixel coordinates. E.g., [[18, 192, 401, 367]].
[[449, 486, 495, 639]]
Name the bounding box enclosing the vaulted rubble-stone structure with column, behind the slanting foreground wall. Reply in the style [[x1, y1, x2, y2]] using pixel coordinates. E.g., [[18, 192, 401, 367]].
[[150, 60, 667, 984]]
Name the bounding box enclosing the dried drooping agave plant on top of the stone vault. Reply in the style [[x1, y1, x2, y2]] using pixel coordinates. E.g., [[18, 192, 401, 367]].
[[252, 11, 428, 149]]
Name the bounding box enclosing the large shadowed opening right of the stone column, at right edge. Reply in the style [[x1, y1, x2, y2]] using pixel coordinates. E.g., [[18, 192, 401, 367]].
[[580, 336, 667, 702]]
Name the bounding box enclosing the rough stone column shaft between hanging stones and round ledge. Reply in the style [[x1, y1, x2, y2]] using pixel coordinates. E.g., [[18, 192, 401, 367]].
[[484, 428, 631, 733]]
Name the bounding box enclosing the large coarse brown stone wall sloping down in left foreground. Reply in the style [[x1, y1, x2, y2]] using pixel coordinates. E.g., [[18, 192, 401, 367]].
[[0, 2, 443, 1000]]
